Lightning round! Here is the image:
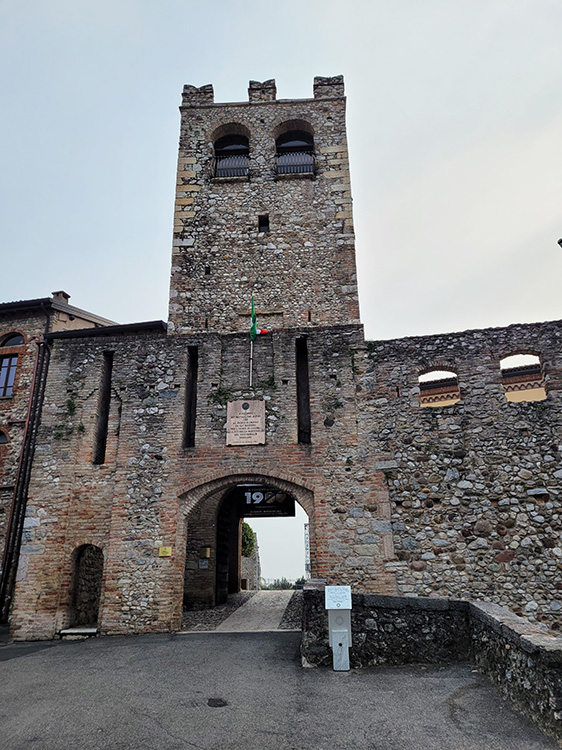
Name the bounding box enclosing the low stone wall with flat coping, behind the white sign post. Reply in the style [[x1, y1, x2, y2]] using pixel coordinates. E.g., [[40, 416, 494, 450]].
[[301, 588, 562, 740]]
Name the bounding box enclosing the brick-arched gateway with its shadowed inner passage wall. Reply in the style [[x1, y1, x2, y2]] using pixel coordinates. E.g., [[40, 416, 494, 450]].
[[180, 474, 316, 607]]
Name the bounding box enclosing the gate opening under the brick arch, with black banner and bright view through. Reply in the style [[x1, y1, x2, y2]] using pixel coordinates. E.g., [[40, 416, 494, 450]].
[[183, 475, 315, 617]]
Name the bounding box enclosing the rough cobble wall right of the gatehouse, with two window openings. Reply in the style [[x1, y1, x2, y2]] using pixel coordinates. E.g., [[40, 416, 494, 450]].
[[358, 322, 562, 628]]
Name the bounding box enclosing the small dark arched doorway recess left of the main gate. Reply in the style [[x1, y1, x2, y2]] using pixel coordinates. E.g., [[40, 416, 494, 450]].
[[69, 544, 103, 627]]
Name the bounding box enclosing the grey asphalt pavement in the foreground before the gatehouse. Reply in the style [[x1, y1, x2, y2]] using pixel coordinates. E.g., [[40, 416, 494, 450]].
[[0, 632, 557, 750]]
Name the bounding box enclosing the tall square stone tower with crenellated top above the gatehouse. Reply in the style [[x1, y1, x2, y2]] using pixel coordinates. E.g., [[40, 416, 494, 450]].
[[169, 76, 359, 333]]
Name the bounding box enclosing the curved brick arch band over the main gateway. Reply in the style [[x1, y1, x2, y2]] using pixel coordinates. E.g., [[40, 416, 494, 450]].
[[179, 472, 314, 519]]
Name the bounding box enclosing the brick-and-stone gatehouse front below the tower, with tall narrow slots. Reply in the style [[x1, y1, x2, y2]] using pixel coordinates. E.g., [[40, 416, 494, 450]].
[[8, 324, 394, 638]]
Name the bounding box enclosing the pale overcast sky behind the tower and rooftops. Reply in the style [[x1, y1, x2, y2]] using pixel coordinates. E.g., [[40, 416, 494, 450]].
[[0, 0, 562, 575]]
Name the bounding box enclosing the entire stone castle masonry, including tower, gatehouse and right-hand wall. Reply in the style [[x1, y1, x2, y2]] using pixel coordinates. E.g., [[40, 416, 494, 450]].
[[0, 77, 562, 639]]
